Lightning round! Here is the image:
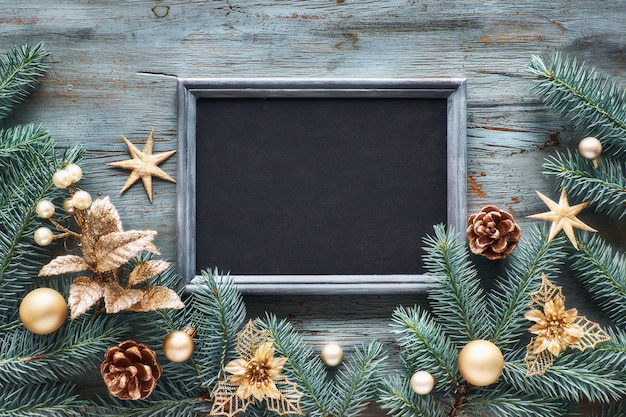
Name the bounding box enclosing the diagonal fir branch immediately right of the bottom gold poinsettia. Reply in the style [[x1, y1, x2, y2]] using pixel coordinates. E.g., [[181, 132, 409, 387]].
[[255, 314, 335, 417]]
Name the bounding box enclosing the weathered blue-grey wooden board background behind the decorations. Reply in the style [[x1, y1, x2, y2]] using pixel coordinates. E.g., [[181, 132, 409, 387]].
[[0, 0, 626, 416]]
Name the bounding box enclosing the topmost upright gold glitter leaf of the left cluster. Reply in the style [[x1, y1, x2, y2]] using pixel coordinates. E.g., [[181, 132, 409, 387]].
[[80, 197, 124, 265]]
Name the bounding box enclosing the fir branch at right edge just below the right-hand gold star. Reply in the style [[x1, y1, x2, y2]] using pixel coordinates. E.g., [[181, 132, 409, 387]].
[[571, 235, 626, 326]]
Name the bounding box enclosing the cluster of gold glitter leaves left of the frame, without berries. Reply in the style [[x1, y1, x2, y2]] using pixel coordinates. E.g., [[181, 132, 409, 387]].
[[39, 197, 184, 319]]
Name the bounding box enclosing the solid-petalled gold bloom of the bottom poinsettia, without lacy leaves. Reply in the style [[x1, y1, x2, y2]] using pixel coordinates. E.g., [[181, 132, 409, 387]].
[[225, 342, 287, 400]]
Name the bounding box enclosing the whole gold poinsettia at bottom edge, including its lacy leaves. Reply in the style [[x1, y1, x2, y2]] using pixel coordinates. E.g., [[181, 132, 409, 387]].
[[210, 321, 302, 417]]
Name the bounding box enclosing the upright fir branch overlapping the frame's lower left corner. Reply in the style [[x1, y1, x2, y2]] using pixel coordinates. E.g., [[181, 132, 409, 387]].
[[185, 271, 246, 387]]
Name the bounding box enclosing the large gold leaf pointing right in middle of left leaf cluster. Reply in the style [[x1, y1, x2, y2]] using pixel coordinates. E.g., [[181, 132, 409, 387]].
[[95, 230, 160, 272]]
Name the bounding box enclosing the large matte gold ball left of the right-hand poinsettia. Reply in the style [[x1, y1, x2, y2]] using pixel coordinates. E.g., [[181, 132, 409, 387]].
[[458, 340, 504, 387]]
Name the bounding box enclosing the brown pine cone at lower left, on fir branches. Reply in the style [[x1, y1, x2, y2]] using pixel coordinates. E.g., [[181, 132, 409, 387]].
[[100, 340, 162, 400]]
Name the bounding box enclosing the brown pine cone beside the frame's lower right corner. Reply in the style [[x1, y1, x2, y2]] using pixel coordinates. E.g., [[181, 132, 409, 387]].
[[467, 206, 522, 260]]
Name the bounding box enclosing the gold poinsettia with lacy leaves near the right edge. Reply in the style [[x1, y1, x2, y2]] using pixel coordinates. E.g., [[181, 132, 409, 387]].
[[524, 274, 611, 377]]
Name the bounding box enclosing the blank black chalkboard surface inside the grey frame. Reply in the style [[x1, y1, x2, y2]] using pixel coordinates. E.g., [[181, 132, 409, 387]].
[[196, 98, 447, 275]]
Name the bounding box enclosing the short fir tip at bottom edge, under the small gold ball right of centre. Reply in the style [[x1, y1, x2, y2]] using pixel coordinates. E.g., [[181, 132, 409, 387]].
[[378, 376, 446, 417]]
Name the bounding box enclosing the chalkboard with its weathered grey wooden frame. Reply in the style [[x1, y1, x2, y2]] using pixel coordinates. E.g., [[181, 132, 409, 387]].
[[179, 80, 466, 293]]
